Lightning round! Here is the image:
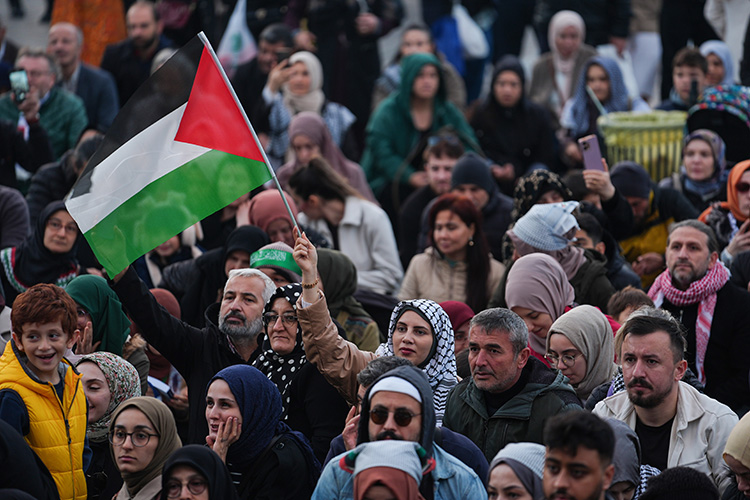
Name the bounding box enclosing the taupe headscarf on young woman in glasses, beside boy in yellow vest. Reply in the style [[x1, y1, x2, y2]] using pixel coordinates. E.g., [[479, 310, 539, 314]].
[[109, 396, 182, 496]]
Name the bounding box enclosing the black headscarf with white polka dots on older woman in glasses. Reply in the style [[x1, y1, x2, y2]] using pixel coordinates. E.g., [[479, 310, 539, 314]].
[[253, 283, 307, 420]]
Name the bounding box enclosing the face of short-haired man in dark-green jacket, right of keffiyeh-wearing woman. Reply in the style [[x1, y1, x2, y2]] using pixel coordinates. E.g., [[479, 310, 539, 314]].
[[469, 326, 529, 393]]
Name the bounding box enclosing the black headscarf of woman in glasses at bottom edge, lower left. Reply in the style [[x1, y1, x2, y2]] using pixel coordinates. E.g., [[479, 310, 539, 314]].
[[161, 444, 239, 500]]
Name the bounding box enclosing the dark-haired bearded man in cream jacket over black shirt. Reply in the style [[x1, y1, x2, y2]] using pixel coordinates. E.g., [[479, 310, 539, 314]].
[[594, 308, 737, 492]]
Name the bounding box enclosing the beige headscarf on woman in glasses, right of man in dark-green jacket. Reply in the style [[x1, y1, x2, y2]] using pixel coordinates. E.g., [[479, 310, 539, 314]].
[[547, 305, 617, 401]]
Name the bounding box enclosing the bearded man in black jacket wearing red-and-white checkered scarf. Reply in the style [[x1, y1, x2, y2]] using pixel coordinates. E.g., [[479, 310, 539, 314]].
[[648, 220, 750, 415]]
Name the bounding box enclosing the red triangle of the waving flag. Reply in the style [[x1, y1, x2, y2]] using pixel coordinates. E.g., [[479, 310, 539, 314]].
[[175, 47, 263, 161]]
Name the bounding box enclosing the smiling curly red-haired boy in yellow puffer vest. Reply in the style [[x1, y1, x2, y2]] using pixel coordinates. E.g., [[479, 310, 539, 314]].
[[0, 284, 87, 500]]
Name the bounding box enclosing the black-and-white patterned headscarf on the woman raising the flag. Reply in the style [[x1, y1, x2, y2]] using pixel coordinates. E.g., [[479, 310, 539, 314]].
[[376, 299, 458, 425]]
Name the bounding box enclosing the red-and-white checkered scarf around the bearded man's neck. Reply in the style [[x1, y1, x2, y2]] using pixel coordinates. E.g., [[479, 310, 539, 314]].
[[648, 261, 729, 384]]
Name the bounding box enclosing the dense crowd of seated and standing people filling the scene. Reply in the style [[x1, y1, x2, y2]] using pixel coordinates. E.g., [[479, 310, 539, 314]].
[[0, 0, 750, 500]]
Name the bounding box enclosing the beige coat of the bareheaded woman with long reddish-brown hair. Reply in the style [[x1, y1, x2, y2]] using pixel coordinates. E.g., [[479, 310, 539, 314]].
[[398, 247, 505, 303]]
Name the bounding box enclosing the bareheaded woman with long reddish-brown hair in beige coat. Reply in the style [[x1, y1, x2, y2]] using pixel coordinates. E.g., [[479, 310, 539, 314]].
[[398, 193, 505, 311]]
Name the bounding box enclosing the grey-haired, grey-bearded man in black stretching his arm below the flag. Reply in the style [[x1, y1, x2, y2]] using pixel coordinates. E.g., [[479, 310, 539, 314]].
[[112, 268, 276, 444]]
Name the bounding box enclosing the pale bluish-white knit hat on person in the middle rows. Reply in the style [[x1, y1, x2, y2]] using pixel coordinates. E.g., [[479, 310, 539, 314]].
[[513, 201, 579, 251]]
